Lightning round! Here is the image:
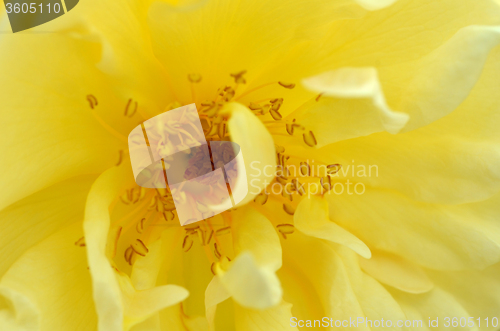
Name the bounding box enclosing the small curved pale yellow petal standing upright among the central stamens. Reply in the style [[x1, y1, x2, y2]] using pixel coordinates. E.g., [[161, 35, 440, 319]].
[[224, 102, 276, 205]]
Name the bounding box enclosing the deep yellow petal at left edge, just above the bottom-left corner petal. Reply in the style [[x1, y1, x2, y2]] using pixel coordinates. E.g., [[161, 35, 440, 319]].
[[0, 176, 96, 276]]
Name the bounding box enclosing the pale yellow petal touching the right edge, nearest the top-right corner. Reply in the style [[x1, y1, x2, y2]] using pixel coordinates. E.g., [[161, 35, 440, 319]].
[[400, 26, 500, 131]]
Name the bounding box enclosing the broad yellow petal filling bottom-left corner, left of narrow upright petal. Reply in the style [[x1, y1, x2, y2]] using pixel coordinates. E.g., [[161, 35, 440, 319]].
[[0, 222, 97, 330]]
